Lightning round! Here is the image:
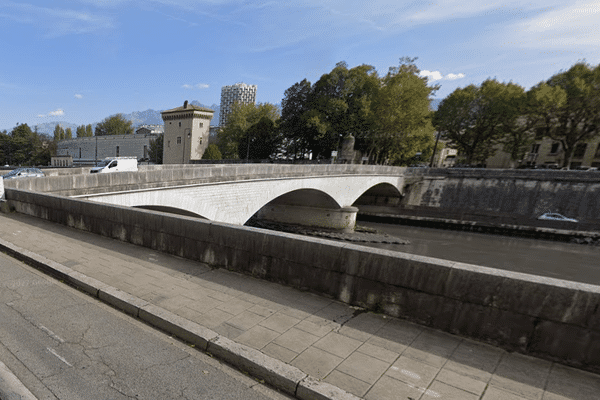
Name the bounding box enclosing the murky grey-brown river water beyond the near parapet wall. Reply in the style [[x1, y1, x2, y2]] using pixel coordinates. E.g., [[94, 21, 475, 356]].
[[358, 221, 600, 285]]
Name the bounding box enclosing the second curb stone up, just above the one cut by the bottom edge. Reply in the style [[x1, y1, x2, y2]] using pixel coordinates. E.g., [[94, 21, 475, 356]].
[[207, 336, 307, 395]]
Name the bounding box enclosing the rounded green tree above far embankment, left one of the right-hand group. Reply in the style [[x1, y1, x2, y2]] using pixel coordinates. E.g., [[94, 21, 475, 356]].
[[434, 79, 524, 164]]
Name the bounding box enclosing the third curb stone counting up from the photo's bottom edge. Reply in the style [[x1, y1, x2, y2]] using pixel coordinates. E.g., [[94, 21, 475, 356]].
[[138, 304, 218, 351]]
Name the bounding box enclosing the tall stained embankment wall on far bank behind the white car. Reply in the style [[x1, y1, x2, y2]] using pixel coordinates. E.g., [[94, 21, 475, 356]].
[[400, 168, 600, 230]]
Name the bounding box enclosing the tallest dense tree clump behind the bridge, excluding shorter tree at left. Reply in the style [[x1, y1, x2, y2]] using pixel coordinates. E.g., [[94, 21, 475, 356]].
[[280, 58, 437, 165]]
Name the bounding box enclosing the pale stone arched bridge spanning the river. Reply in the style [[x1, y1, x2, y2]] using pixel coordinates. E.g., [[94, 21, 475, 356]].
[[4, 164, 405, 229]]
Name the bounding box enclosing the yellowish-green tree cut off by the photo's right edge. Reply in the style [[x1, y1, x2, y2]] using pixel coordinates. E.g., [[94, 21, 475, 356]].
[[531, 62, 600, 168]]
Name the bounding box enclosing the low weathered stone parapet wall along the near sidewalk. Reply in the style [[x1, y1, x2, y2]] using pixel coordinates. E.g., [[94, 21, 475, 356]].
[[6, 188, 600, 372]]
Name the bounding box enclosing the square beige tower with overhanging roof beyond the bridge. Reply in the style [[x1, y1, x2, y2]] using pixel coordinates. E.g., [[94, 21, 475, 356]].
[[161, 100, 214, 164]]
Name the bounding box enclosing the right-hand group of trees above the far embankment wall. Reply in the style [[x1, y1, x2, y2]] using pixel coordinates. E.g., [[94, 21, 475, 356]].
[[433, 62, 600, 167]]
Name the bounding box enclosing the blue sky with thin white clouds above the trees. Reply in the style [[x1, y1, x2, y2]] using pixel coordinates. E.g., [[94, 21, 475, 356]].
[[0, 0, 600, 130]]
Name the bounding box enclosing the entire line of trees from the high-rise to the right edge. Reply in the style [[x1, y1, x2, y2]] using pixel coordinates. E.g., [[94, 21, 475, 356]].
[[217, 58, 600, 166]]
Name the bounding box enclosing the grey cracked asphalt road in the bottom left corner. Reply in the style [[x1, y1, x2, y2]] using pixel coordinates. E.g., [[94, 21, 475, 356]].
[[0, 253, 290, 400]]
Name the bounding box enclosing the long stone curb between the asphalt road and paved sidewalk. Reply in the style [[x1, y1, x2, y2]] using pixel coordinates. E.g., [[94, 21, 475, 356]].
[[0, 239, 360, 400]]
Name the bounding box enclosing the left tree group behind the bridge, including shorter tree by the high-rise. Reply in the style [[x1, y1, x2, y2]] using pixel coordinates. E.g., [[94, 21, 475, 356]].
[[217, 58, 438, 165]]
